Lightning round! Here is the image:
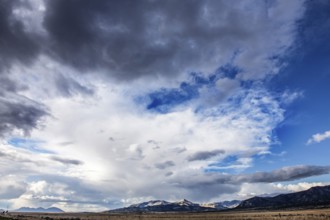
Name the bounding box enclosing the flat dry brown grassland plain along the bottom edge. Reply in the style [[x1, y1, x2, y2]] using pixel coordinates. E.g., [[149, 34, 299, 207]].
[[0, 209, 330, 220]]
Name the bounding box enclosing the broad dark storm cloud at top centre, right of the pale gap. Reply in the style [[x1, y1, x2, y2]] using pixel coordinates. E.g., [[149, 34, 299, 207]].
[[44, 0, 262, 80]]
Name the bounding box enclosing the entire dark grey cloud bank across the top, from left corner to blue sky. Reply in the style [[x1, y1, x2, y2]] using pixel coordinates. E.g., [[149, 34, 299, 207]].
[[0, 0, 304, 81]]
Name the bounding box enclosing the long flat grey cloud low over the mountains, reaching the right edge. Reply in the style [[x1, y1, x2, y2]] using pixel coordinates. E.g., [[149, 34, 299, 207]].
[[171, 165, 330, 201]]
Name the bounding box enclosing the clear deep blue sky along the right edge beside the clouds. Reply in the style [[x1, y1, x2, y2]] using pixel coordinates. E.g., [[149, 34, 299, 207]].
[[269, 0, 330, 168]]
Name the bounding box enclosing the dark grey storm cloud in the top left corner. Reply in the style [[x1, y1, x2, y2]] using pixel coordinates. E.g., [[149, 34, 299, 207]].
[[0, 0, 39, 73]]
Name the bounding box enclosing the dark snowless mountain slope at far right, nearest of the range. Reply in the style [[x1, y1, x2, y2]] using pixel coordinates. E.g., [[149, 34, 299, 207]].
[[237, 186, 330, 209]]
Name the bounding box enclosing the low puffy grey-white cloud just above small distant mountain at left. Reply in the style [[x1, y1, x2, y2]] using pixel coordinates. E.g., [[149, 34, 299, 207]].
[[11, 175, 112, 211]]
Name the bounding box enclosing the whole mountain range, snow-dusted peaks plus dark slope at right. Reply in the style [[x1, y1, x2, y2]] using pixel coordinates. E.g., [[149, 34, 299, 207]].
[[109, 185, 330, 213]]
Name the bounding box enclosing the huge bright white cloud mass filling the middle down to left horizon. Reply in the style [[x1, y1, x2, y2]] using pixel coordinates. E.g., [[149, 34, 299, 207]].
[[1, 69, 283, 211]]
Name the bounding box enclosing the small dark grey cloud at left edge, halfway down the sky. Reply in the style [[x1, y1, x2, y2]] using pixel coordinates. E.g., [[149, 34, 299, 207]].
[[0, 90, 48, 136]]
